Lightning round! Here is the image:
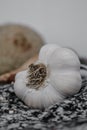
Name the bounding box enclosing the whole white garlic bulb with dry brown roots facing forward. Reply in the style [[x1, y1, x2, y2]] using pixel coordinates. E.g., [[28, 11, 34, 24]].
[[14, 44, 81, 108]]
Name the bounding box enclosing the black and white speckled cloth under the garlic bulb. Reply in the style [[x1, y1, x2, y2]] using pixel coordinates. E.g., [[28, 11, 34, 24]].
[[0, 60, 87, 130]]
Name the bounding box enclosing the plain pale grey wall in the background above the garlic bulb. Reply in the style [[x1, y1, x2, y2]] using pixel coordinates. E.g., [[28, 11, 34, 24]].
[[0, 0, 87, 57]]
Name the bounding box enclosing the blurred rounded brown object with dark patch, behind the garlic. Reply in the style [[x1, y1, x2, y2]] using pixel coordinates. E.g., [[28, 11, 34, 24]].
[[0, 24, 44, 75]]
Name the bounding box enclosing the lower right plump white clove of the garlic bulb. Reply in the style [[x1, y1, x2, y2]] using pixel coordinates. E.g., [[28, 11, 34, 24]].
[[50, 71, 82, 95]]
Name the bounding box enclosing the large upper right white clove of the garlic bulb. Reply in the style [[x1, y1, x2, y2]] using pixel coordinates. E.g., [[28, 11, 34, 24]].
[[48, 48, 80, 71]]
